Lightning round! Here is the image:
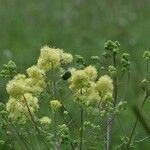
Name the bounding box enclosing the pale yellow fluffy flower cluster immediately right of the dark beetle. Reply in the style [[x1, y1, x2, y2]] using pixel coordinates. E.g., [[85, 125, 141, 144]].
[[69, 65, 113, 106]]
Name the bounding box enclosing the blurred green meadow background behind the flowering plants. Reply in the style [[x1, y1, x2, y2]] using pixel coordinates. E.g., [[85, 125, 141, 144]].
[[0, 0, 150, 150]]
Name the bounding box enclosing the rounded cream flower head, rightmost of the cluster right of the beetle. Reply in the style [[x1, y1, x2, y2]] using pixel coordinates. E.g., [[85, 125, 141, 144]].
[[96, 75, 113, 93]]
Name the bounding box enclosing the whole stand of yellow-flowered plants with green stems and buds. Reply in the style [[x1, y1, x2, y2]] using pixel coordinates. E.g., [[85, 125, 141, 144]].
[[0, 40, 150, 150]]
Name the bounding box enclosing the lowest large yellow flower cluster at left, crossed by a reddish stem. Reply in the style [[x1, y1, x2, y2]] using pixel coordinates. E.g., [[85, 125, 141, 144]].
[[6, 93, 39, 124]]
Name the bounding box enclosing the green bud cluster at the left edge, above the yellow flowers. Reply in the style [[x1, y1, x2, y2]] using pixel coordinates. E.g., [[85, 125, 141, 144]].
[[0, 60, 17, 79]]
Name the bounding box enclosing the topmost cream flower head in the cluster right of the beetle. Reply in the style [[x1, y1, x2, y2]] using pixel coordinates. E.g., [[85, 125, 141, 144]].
[[84, 65, 97, 80]]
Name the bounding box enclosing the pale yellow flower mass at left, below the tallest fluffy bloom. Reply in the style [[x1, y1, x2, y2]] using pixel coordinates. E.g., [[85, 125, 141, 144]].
[[6, 66, 46, 123]]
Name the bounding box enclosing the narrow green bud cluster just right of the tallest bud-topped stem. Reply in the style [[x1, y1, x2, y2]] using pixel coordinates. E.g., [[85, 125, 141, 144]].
[[121, 53, 130, 70]]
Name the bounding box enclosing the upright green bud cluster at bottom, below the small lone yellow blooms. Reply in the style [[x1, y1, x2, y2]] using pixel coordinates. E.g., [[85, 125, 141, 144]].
[[58, 124, 69, 144]]
